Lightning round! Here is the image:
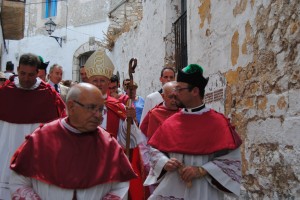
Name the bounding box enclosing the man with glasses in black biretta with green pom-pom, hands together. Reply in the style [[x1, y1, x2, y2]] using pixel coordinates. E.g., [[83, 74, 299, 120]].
[[146, 64, 242, 200]]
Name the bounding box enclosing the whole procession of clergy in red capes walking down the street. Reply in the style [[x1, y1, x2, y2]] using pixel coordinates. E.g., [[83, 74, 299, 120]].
[[0, 50, 242, 200]]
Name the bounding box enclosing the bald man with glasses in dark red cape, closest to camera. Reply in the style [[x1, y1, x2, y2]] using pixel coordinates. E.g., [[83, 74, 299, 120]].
[[10, 83, 136, 200]]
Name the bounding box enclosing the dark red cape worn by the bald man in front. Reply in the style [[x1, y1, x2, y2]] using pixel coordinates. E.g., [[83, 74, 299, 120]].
[[10, 119, 136, 189]]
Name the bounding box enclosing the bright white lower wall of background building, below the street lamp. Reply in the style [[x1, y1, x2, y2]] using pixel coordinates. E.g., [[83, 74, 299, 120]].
[[2, 22, 108, 80]]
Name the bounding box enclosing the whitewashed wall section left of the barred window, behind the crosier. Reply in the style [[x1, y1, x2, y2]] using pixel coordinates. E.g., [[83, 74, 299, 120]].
[[108, 0, 180, 97]]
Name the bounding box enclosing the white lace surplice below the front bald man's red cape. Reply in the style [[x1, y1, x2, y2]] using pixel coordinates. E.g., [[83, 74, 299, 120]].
[[10, 172, 129, 200]]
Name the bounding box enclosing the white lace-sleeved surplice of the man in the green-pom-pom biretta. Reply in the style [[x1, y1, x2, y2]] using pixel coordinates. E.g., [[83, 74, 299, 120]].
[[144, 148, 241, 200]]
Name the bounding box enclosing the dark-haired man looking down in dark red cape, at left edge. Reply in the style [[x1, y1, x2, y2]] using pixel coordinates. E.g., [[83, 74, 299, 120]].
[[0, 53, 65, 199]]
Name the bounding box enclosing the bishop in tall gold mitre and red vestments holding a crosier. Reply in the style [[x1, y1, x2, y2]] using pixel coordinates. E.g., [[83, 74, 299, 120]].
[[84, 50, 144, 200]]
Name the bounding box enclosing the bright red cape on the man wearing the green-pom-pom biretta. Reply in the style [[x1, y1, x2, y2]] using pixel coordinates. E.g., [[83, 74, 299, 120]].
[[149, 110, 242, 155]]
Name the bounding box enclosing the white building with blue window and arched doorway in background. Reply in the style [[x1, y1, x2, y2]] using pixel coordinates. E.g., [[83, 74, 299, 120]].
[[1, 0, 109, 81]]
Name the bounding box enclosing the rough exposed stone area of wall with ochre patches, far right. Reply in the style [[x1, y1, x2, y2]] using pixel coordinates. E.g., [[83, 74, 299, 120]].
[[225, 1, 300, 199]]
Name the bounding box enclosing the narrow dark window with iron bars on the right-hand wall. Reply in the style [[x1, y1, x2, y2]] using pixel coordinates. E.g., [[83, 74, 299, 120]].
[[173, 0, 188, 70]]
